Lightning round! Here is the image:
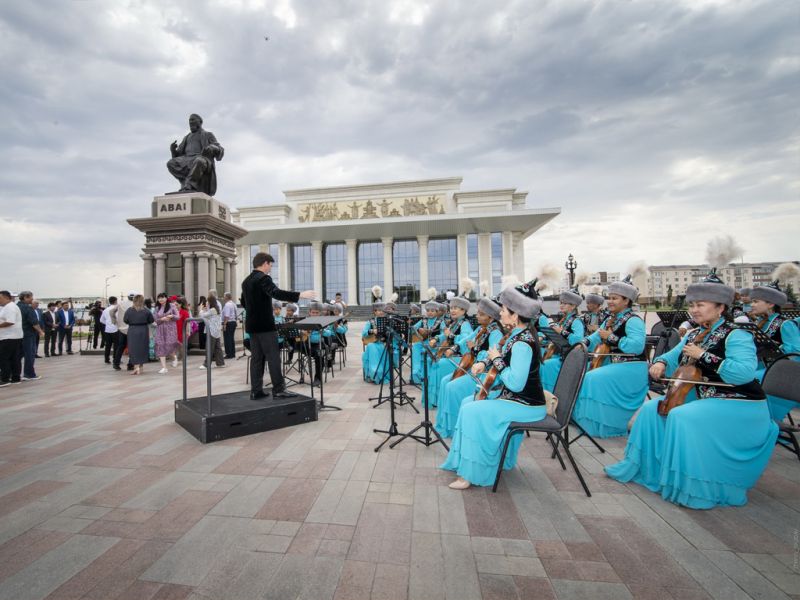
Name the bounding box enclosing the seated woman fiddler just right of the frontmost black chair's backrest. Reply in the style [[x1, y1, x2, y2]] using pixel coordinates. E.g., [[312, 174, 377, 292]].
[[573, 275, 649, 438]]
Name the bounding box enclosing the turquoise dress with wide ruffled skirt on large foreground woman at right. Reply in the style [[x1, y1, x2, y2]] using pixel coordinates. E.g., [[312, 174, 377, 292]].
[[605, 319, 778, 509]]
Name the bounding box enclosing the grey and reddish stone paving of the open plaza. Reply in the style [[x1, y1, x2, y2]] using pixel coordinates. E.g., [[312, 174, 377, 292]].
[[0, 332, 800, 600]]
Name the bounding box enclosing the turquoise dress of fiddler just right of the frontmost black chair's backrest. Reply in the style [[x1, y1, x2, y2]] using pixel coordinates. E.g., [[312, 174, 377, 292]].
[[573, 308, 649, 438]]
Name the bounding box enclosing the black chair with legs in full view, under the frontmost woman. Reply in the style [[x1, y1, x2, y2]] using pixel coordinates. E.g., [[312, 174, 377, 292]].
[[492, 344, 592, 497]]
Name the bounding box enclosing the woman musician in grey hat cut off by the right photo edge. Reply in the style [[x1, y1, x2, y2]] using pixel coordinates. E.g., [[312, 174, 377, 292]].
[[749, 263, 800, 421]]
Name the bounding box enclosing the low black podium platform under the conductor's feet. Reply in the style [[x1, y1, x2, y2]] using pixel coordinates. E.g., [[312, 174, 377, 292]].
[[175, 390, 317, 444]]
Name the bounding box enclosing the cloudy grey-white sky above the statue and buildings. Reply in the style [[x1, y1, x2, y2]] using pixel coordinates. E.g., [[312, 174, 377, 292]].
[[0, 0, 800, 296]]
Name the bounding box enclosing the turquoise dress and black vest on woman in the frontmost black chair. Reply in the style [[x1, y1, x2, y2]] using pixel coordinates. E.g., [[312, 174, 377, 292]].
[[441, 327, 547, 485]]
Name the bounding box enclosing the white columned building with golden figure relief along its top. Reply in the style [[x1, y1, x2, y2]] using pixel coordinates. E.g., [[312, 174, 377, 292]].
[[232, 177, 561, 304]]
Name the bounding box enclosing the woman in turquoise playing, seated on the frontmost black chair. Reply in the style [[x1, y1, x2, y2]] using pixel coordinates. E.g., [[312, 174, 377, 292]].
[[441, 284, 547, 490]]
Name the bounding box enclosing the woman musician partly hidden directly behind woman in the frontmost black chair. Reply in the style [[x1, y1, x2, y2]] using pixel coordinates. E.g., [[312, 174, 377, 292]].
[[436, 297, 503, 438]]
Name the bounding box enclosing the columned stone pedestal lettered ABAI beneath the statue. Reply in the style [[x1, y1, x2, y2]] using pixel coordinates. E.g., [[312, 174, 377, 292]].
[[128, 192, 247, 306]]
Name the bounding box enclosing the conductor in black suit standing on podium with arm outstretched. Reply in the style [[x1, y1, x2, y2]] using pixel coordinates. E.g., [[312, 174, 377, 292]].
[[241, 252, 317, 400]]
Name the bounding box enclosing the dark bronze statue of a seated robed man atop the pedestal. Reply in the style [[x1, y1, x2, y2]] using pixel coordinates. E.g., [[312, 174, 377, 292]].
[[167, 114, 225, 196]]
